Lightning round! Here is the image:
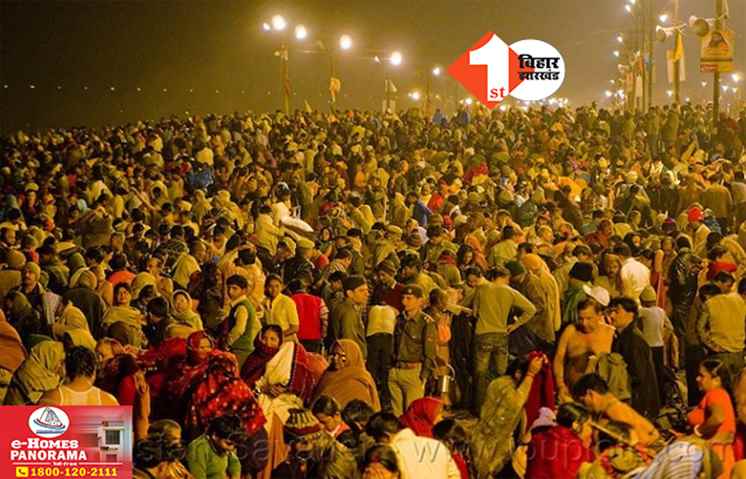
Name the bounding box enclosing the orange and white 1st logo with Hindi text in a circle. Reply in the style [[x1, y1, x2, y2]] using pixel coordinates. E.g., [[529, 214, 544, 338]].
[[448, 32, 565, 109]]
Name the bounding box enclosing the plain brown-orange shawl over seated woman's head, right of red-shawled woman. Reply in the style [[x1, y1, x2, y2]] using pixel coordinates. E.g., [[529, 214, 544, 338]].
[[314, 339, 381, 411]]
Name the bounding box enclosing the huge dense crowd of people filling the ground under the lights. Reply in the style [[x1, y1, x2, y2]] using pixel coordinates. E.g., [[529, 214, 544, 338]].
[[0, 104, 746, 479]]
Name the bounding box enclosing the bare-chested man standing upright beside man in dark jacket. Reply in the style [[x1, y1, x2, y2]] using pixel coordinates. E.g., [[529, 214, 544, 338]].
[[554, 298, 614, 402]]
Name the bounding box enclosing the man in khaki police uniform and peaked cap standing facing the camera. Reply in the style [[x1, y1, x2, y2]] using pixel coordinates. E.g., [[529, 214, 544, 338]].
[[388, 284, 438, 416]]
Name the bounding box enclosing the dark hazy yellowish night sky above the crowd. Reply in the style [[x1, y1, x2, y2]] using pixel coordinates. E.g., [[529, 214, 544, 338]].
[[0, 0, 746, 131]]
